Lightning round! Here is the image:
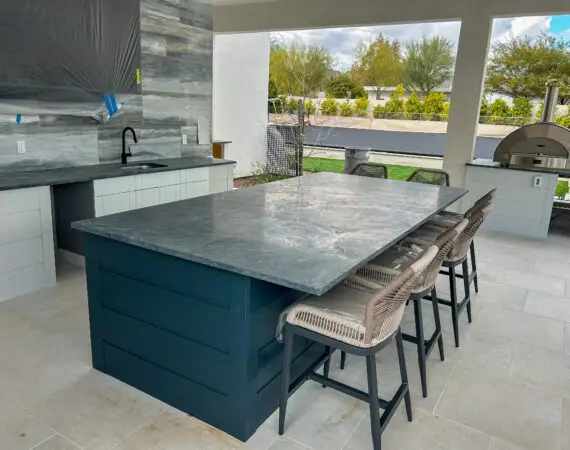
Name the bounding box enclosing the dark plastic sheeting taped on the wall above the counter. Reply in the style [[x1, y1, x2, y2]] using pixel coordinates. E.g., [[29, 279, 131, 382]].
[[0, 0, 141, 124]]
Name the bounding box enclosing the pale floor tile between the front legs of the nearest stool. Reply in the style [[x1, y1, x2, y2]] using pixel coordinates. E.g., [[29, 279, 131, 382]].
[[266, 381, 367, 450]]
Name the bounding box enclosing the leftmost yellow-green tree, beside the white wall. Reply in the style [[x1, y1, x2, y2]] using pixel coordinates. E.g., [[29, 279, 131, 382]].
[[269, 43, 332, 99]]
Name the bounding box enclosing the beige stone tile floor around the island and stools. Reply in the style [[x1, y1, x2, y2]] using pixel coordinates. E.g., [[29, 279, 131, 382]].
[[0, 227, 570, 450]]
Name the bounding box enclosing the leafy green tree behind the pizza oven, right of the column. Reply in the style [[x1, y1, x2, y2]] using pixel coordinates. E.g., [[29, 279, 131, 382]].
[[486, 34, 570, 105]]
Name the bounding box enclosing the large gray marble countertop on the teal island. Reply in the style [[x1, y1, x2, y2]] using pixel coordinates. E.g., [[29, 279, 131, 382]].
[[73, 172, 467, 295]]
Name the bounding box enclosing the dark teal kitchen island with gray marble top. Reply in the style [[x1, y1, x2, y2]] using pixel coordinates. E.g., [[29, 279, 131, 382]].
[[74, 173, 466, 441]]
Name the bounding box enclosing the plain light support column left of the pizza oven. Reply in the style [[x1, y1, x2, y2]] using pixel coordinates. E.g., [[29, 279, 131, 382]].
[[443, 11, 493, 186]]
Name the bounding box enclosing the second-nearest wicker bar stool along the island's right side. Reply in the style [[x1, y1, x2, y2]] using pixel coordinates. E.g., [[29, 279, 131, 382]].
[[341, 219, 469, 397]]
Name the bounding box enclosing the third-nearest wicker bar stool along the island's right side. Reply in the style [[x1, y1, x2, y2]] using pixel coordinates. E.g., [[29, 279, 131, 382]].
[[405, 204, 493, 347]]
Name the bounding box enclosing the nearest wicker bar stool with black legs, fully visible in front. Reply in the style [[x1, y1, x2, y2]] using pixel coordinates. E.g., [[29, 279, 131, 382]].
[[279, 246, 438, 450]]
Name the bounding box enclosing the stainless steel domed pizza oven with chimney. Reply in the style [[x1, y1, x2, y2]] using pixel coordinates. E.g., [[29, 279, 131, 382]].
[[493, 81, 570, 169]]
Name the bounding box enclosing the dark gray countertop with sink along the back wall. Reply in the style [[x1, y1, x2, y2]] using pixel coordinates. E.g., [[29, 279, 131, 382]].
[[0, 156, 235, 191]]
